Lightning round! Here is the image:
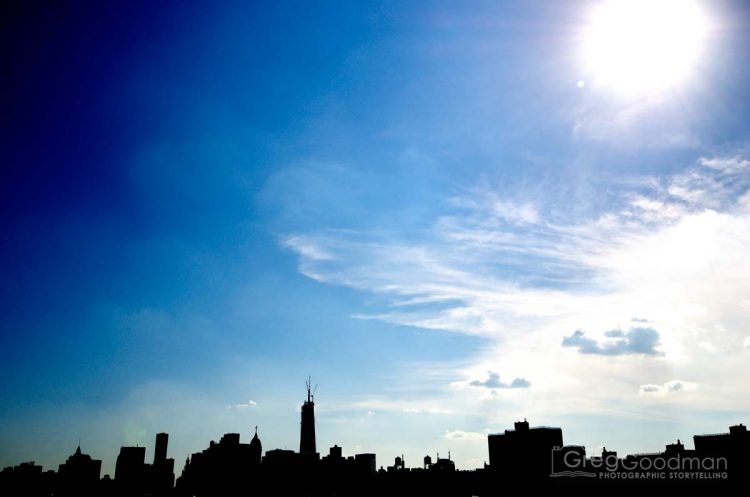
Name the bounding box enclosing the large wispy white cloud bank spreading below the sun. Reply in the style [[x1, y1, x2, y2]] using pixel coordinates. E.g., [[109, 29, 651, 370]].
[[287, 154, 750, 412]]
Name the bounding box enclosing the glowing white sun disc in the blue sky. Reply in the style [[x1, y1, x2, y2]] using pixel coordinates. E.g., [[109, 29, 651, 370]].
[[579, 0, 708, 95]]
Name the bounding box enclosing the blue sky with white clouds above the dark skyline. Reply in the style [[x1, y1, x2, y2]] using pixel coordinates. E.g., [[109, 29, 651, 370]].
[[0, 0, 750, 472]]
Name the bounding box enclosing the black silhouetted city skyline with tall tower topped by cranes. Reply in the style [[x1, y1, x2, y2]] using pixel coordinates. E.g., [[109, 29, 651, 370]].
[[0, 379, 750, 496]]
